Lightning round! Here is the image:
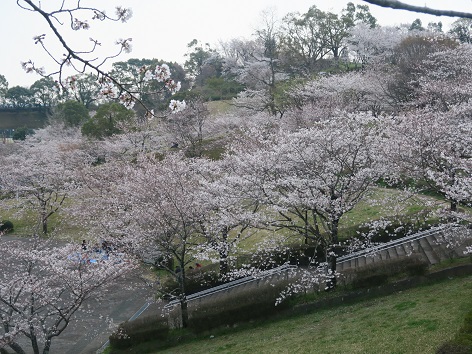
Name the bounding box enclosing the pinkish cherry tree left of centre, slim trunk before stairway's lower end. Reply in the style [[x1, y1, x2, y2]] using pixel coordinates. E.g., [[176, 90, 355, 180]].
[[68, 154, 212, 327]]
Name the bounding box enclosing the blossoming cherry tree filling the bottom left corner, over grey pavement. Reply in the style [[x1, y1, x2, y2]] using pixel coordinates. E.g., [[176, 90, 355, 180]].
[[0, 239, 134, 354]]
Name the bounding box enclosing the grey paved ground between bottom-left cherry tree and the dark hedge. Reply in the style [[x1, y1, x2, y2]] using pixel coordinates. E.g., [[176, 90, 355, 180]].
[[0, 236, 157, 354]]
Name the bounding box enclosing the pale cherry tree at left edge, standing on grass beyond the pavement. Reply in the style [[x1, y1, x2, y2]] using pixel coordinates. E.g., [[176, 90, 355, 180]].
[[0, 127, 89, 234]]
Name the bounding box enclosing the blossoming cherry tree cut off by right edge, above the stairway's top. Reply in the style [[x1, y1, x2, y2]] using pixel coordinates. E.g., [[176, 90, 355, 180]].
[[385, 104, 472, 212]]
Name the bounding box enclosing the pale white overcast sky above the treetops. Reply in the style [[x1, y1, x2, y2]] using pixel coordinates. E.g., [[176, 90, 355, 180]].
[[0, 0, 472, 87]]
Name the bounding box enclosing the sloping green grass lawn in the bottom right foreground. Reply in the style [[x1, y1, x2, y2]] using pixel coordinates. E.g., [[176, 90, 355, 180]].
[[113, 276, 472, 354]]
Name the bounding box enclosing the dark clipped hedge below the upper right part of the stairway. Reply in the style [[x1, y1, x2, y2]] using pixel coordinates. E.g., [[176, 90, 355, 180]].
[[351, 256, 428, 289]]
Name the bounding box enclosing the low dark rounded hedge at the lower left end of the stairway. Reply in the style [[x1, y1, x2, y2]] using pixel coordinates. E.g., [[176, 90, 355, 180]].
[[110, 316, 169, 349]]
